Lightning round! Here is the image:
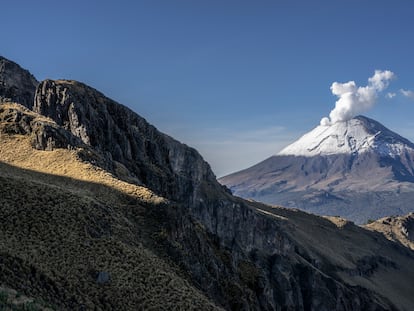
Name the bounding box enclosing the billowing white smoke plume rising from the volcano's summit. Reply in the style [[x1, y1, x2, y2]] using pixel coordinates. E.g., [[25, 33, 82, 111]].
[[321, 70, 395, 126]]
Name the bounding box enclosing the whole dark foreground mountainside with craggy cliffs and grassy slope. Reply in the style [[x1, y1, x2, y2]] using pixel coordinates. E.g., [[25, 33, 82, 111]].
[[0, 56, 414, 311]]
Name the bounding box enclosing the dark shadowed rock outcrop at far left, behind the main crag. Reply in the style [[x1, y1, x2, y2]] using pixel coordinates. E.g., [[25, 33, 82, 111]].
[[0, 56, 39, 108]]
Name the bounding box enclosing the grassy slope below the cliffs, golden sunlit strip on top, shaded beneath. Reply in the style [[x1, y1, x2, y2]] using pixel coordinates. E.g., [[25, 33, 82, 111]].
[[0, 134, 222, 310]]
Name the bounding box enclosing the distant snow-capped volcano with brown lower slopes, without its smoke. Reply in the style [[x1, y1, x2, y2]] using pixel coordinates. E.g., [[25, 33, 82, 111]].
[[220, 116, 414, 223]]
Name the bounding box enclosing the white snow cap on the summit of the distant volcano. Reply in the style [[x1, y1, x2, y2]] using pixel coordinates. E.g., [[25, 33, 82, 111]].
[[278, 116, 414, 158]]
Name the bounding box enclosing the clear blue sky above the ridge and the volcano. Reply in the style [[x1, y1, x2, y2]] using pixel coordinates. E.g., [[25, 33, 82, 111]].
[[0, 0, 414, 176]]
